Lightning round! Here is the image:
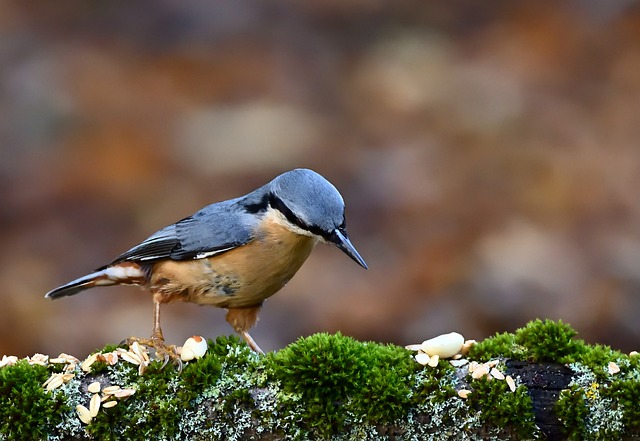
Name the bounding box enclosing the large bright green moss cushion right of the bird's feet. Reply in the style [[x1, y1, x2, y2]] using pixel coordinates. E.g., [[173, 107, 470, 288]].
[[268, 334, 416, 438]]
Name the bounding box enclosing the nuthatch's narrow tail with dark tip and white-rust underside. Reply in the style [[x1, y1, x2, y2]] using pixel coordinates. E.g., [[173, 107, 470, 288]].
[[45, 262, 147, 299]]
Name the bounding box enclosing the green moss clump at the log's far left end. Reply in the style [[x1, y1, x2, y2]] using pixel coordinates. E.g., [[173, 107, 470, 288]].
[[0, 360, 67, 440]]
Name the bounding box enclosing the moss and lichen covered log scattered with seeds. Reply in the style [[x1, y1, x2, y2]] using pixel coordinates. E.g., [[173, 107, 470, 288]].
[[0, 320, 640, 440]]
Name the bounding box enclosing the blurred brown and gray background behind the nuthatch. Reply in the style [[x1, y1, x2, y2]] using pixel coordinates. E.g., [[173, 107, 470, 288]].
[[0, 0, 640, 356]]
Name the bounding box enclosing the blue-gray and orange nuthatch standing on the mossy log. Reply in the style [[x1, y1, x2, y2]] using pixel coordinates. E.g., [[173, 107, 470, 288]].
[[45, 169, 367, 359]]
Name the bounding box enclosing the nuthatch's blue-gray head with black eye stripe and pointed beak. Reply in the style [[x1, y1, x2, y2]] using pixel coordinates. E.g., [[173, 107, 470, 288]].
[[268, 168, 367, 268]]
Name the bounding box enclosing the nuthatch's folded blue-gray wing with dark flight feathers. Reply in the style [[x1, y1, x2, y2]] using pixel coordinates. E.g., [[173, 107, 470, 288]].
[[101, 200, 253, 266]]
